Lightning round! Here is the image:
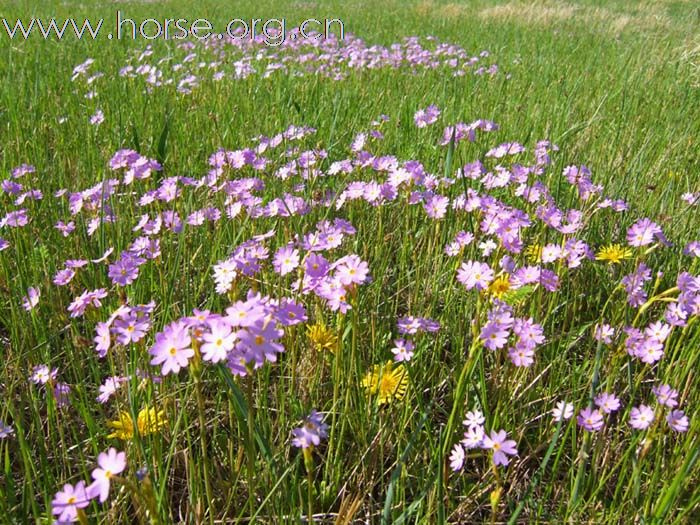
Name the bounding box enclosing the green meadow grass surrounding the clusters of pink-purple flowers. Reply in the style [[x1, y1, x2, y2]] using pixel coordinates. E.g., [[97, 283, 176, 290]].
[[0, 1, 700, 523]]
